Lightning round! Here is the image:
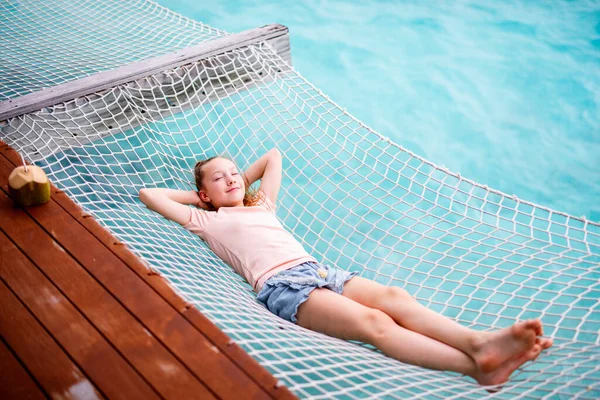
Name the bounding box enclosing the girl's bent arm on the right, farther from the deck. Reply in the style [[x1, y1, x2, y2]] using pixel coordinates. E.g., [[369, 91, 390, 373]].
[[243, 148, 282, 204]]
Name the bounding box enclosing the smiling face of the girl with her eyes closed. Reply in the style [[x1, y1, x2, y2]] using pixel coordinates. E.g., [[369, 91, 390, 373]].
[[198, 158, 246, 210]]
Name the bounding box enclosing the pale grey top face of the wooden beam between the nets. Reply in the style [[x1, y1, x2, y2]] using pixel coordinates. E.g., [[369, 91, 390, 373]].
[[0, 24, 291, 121]]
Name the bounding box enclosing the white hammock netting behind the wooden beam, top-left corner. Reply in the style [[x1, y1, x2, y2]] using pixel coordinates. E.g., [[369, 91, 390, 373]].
[[0, 0, 226, 101]]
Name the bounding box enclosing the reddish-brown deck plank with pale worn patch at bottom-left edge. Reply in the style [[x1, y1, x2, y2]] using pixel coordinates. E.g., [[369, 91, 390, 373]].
[[0, 280, 103, 399]]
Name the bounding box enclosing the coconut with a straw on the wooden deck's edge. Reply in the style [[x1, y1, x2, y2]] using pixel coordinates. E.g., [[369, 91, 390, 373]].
[[8, 165, 50, 207]]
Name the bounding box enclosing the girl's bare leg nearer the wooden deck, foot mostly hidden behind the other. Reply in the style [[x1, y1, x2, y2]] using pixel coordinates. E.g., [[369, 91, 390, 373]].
[[298, 289, 541, 385]]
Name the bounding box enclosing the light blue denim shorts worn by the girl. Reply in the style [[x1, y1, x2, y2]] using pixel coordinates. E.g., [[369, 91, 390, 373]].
[[257, 261, 357, 323]]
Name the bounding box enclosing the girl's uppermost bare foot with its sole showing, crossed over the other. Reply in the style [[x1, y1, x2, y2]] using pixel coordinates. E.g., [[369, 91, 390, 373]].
[[470, 319, 542, 372]]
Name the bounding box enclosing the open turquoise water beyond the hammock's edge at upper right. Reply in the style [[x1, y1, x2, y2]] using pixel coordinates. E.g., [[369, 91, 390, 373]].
[[158, 0, 600, 221]]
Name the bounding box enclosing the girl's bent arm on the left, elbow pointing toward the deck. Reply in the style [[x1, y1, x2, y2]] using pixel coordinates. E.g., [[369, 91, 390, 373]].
[[140, 188, 202, 225]]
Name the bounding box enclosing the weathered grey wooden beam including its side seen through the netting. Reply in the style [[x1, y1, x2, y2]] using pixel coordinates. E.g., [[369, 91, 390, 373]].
[[0, 24, 291, 163]]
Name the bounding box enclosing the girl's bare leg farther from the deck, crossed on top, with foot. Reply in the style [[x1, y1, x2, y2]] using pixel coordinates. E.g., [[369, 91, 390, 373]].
[[343, 277, 552, 372]]
